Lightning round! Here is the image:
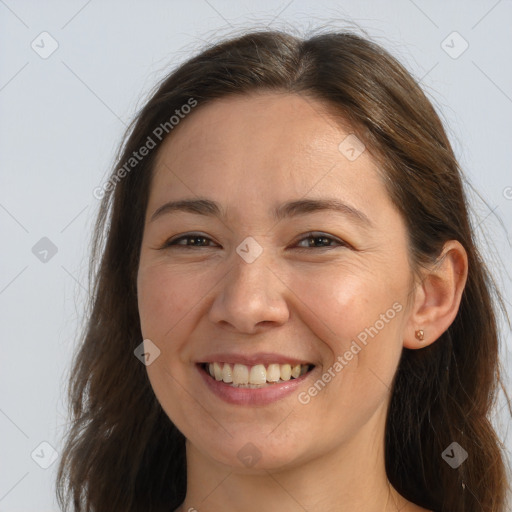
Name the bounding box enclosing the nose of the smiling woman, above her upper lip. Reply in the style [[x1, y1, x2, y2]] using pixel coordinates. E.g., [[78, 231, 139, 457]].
[[208, 246, 289, 334]]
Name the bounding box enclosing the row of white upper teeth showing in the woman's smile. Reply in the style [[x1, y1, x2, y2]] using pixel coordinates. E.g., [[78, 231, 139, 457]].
[[208, 363, 309, 386]]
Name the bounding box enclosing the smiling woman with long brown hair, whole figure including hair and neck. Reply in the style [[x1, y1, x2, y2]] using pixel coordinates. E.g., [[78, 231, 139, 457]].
[[54, 32, 508, 512]]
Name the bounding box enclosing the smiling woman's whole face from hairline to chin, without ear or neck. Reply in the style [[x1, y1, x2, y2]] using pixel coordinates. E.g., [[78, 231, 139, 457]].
[[137, 93, 411, 469]]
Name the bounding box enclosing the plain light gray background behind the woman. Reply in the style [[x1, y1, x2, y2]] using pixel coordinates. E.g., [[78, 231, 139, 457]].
[[0, 0, 512, 512]]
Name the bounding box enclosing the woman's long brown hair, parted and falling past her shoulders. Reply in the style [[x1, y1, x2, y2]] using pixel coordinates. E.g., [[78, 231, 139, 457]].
[[57, 31, 508, 512]]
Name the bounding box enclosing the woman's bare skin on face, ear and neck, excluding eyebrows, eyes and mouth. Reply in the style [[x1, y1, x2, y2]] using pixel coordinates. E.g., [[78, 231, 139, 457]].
[[137, 92, 467, 512]]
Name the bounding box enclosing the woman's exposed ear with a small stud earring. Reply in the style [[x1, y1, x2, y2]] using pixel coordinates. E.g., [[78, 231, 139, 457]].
[[404, 240, 468, 349]]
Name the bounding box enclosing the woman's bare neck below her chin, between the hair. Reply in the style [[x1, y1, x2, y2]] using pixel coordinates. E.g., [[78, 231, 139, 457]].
[[178, 404, 416, 512]]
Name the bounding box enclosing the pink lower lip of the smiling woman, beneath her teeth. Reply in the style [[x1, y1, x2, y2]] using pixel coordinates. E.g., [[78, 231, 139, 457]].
[[196, 365, 315, 405]]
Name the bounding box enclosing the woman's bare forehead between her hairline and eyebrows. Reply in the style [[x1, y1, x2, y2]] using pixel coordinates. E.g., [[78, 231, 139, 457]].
[[150, 92, 385, 222]]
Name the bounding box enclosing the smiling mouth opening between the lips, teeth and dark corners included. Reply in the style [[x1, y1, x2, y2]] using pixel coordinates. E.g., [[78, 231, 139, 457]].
[[198, 361, 315, 389]]
